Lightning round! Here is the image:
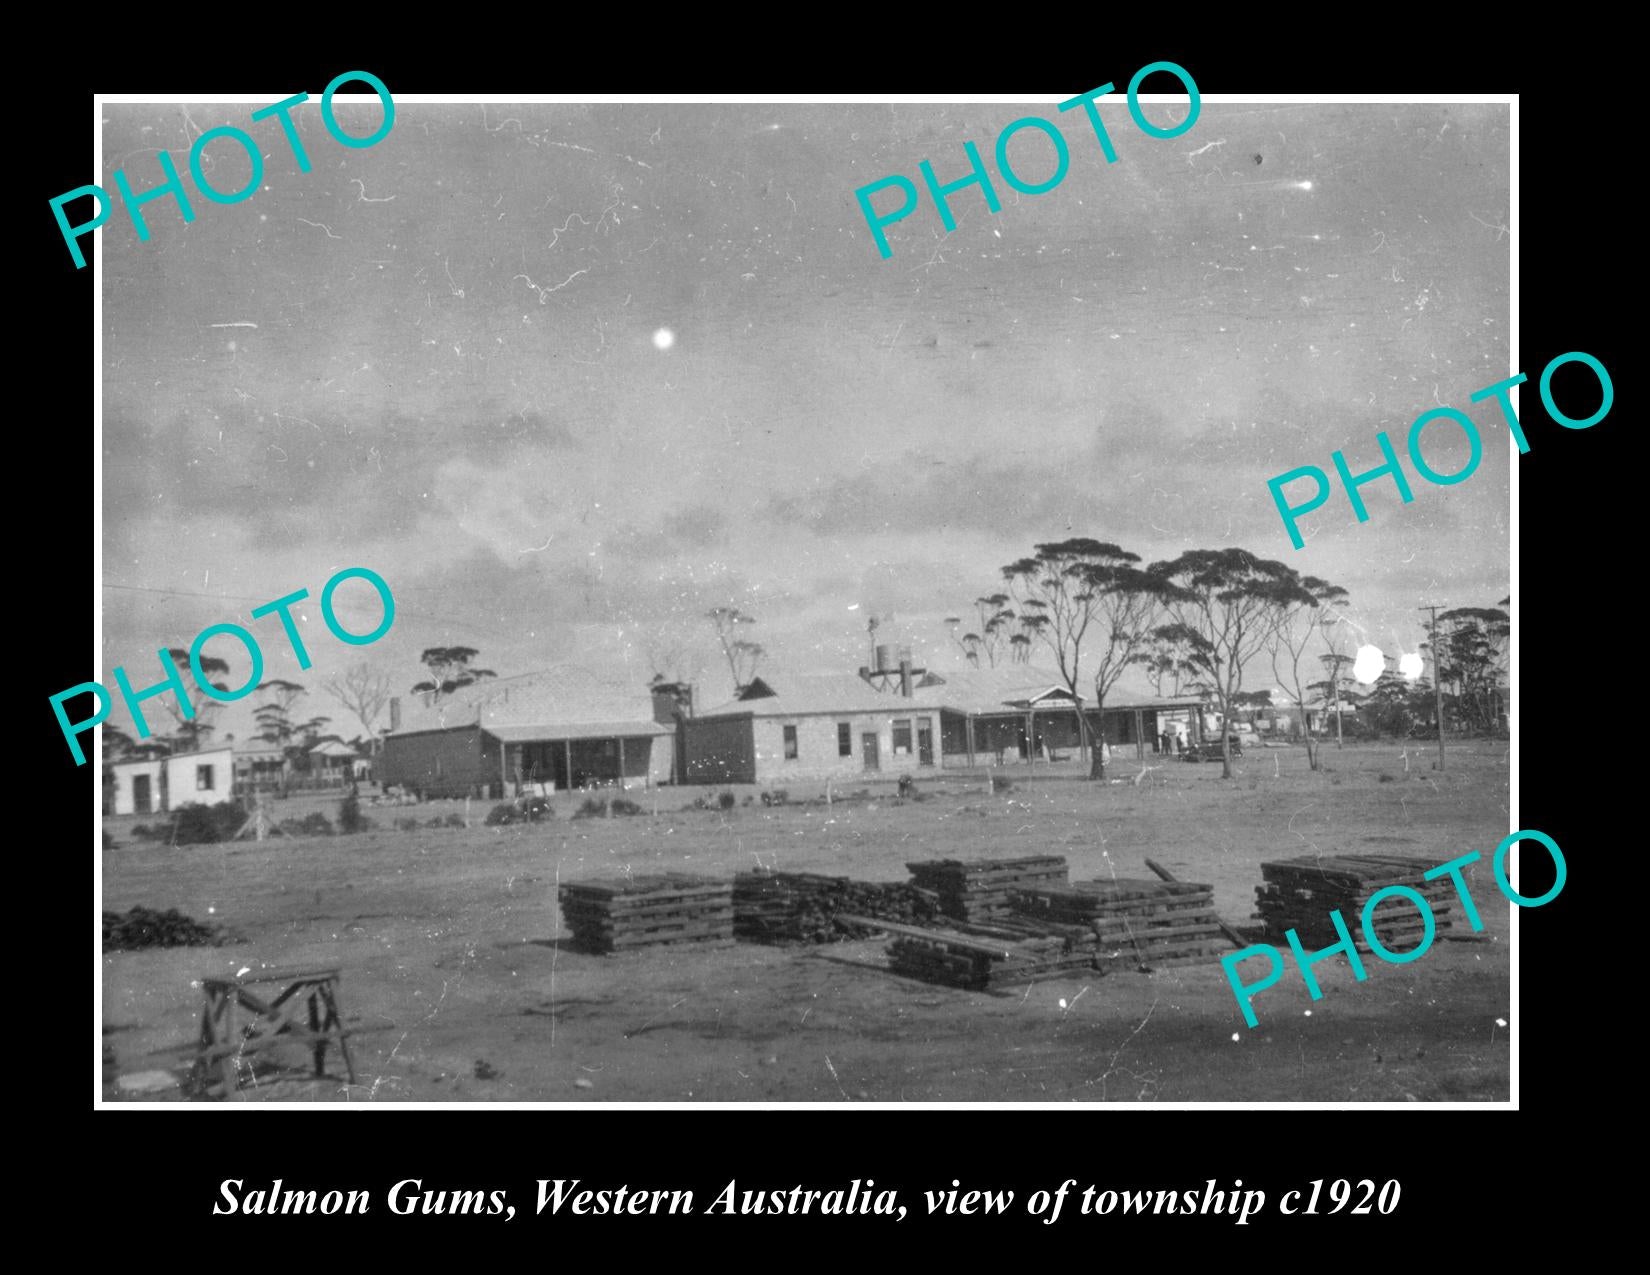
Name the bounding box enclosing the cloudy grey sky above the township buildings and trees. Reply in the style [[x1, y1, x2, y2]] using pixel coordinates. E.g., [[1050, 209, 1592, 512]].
[[97, 96, 1504, 735]]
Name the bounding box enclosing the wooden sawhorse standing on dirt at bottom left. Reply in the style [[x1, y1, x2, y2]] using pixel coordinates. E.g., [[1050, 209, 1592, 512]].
[[195, 970, 355, 1099]]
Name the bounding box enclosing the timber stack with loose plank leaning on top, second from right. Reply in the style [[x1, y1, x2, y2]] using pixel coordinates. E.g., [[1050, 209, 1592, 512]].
[[1013, 877, 1233, 973]]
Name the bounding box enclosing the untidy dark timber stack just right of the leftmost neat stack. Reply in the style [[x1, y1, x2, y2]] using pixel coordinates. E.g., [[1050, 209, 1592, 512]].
[[733, 873, 937, 943]]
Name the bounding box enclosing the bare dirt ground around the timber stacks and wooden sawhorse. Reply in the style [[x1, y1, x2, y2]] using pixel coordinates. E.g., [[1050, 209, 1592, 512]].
[[102, 742, 1511, 1103]]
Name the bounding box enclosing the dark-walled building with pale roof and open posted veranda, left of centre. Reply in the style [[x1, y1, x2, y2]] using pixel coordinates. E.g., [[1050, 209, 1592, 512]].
[[375, 665, 675, 798]]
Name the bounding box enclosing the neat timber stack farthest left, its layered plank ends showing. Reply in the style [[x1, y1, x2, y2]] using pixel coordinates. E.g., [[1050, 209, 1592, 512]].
[[561, 873, 733, 952]]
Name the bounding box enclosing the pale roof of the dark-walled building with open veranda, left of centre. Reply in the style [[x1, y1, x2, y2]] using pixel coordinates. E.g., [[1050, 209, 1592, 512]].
[[391, 665, 668, 739]]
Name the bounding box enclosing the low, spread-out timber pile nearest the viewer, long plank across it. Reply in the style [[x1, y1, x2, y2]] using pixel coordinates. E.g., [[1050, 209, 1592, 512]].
[[883, 919, 1096, 991]]
